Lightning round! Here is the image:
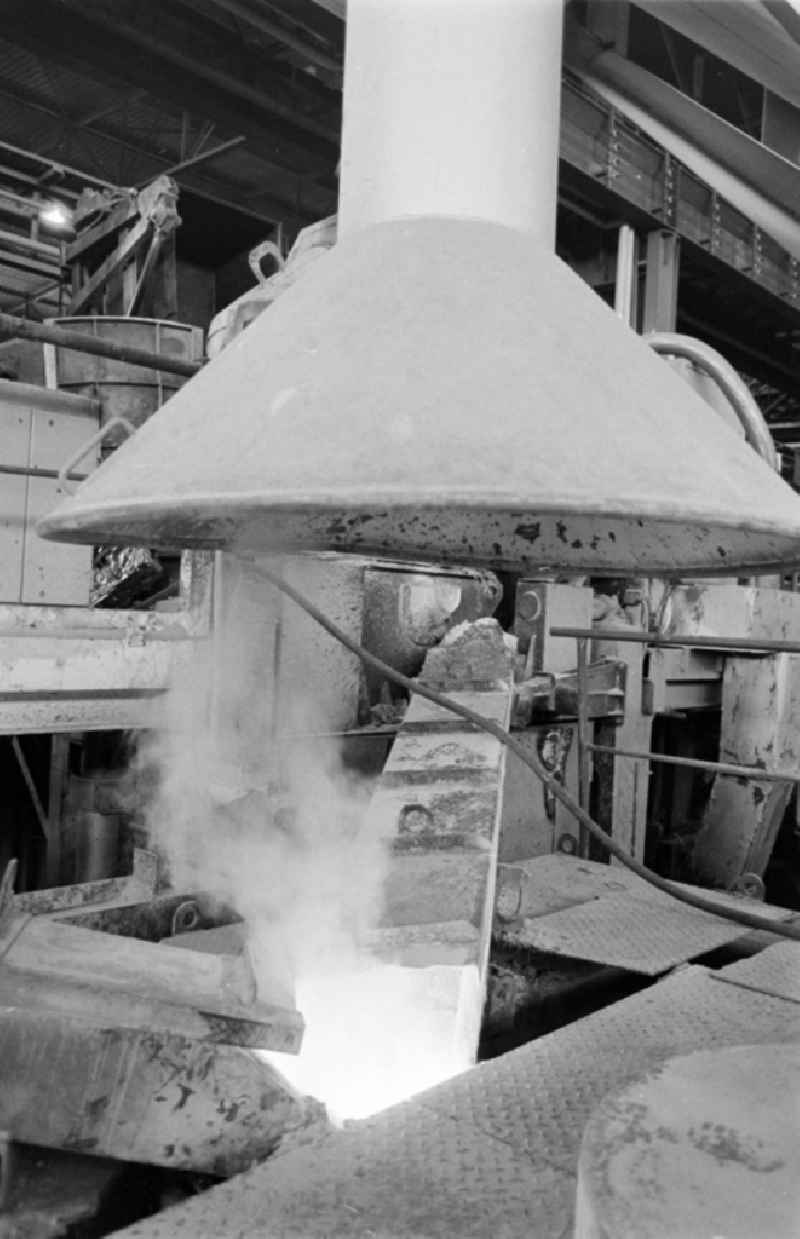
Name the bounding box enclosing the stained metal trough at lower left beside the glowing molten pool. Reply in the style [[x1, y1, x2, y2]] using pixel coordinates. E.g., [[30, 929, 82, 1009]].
[[0, 852, 310, 1175]]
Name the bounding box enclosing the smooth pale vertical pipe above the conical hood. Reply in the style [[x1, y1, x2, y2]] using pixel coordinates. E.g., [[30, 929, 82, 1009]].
[[339, 0, 563, 249]]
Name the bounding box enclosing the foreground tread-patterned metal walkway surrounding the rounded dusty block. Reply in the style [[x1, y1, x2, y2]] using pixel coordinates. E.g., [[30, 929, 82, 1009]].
[[120, 943, 800, 1239]]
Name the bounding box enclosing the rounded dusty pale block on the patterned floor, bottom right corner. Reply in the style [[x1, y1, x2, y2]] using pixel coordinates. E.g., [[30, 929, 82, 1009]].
[[576, 1044, 800, 1239]]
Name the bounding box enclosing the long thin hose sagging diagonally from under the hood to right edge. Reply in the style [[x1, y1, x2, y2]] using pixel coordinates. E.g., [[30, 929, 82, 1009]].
[[258, 564, 800, 942]]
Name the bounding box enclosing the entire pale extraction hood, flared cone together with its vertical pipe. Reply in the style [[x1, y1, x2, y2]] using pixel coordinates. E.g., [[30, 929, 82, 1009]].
[[40, 0, 800, 575]]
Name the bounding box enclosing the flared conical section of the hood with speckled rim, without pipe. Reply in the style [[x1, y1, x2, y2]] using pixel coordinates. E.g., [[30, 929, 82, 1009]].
[[40, 218, 800, 575]]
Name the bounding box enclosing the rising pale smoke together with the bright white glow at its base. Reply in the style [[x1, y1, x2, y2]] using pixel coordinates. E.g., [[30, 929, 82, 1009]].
[[134, 556, 477, 1120]]
